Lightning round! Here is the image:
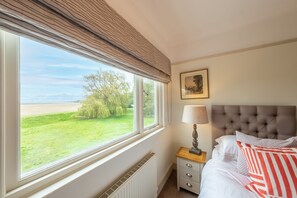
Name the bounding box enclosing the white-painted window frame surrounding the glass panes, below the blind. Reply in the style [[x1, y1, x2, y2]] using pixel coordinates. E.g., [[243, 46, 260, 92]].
[[0, 29, 164, 197]]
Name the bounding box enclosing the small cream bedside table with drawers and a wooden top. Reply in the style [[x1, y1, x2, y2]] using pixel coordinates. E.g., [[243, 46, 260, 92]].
[[176, 147, 206, 194]]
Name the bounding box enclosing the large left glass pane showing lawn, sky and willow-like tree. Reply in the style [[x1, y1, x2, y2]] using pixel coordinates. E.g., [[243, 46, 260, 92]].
[[19, 37, 134, 174]]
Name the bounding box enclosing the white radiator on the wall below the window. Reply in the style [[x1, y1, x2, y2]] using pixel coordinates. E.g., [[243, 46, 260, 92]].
[[99, 153, 157, 198]]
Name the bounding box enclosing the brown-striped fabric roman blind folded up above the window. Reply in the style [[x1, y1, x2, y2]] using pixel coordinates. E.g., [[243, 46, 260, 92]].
[[0, 0, 171, 83]]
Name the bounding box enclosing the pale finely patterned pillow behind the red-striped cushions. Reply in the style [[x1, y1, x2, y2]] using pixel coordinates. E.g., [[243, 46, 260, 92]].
[[236, 131, 297, 175]]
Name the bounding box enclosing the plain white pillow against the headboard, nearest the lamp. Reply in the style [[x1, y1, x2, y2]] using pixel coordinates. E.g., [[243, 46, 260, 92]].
[[215, 135, 238, 161]]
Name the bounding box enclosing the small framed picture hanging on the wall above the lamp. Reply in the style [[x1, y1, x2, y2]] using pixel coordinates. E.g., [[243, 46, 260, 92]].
[[180, 69, 209, 99]]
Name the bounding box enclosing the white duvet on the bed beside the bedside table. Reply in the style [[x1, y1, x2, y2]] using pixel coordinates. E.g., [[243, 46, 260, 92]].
[[199, 151, 257, 198]]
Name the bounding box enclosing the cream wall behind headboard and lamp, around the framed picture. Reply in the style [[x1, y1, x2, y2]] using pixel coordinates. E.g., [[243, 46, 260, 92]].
[[172, 42, 297, 159]]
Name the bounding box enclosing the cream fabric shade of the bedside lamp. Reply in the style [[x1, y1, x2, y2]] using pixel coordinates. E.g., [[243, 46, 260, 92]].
[[182, 105, 208, 124]]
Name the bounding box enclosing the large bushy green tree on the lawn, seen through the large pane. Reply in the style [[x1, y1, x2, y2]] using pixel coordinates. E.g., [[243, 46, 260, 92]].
[[78, 70, 130, 118]]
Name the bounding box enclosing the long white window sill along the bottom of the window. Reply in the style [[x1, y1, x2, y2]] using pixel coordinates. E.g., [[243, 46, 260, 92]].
[[5, 126, 164, 198]]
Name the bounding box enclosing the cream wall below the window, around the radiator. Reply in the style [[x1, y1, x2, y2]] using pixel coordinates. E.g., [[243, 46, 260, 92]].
[[45, 127, 173, 198]]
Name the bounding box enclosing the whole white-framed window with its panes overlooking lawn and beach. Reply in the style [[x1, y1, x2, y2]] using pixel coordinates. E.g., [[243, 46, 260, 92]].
[[0, 30, 162, 193]]
